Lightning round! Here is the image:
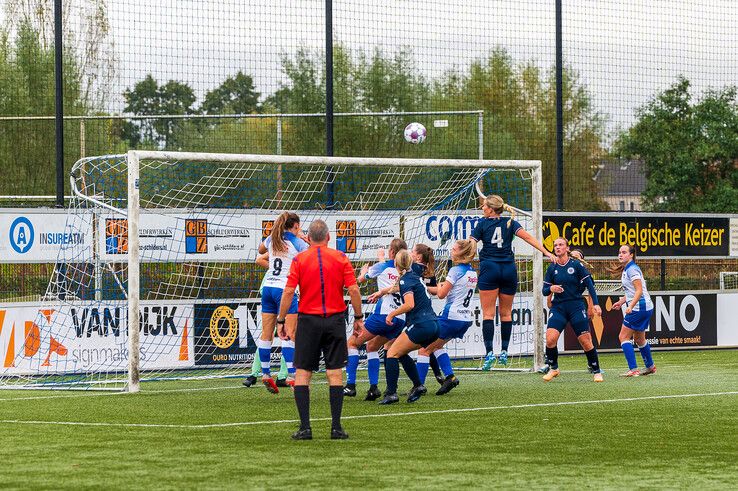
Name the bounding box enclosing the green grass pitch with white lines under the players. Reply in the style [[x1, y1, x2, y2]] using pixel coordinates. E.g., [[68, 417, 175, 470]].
[[0, 350, 738, 489]]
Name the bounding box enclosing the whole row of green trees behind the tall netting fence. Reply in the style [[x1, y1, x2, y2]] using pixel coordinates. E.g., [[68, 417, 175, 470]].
[[0, 12, 738, 212]]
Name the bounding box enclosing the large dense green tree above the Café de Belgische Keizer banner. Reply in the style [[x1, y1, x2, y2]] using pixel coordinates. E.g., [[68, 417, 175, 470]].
[[614, 77, 738, 213]]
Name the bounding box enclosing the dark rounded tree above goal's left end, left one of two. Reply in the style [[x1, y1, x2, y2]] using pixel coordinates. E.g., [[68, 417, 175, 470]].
[[123, 74, 196, 148]]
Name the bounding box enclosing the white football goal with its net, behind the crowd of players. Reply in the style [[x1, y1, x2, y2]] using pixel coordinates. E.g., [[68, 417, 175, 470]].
[[0, 151, 544, 391]]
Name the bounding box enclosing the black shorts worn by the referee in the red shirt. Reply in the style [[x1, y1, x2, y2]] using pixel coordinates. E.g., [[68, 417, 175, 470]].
[[294, 312, 348, 372]]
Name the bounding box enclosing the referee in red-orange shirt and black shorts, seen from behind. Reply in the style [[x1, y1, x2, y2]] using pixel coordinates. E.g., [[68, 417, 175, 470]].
[[277, 220, 364, 440]]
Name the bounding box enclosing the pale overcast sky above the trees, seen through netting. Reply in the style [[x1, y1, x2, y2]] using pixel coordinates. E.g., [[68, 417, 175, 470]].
[[5, 0, 738, 144]]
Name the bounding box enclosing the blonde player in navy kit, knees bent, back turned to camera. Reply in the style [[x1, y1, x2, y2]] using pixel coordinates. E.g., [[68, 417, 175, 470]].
[[379, 250, 438, 404]]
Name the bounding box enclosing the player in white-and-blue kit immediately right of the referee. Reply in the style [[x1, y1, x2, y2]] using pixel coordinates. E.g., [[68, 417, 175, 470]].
[[343, 238, 412, 401]]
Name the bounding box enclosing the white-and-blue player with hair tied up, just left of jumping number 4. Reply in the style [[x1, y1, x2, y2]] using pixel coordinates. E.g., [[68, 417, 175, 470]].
[[418, 240, 477, 396]]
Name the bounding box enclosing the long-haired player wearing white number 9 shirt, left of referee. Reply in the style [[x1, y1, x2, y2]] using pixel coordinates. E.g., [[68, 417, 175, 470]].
[[256, 211, 308, 394]]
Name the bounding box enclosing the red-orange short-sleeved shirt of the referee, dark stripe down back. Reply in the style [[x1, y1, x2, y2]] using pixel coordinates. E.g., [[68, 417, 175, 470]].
[[287, 245, 356, 316]]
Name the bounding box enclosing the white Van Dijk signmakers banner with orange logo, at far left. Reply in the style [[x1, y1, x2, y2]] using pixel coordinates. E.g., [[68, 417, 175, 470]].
[[0, 302, 194, 375]]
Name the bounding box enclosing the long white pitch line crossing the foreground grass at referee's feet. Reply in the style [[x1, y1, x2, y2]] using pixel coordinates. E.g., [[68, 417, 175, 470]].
[[0, 391, 738, 429]]
